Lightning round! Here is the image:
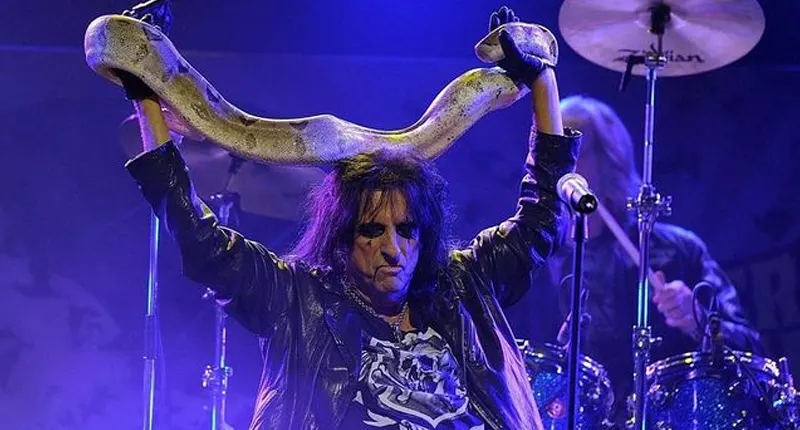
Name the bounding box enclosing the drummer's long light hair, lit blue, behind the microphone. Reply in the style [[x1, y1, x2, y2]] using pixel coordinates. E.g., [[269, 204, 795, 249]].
[[561, 95, 641, 225]]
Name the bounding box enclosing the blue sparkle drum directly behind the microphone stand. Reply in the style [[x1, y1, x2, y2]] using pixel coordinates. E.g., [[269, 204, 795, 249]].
[[517, 339, 614, 430]]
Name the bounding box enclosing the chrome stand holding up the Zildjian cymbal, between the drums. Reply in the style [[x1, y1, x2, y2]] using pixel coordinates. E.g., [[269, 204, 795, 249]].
[[620, 2, 672, 430]]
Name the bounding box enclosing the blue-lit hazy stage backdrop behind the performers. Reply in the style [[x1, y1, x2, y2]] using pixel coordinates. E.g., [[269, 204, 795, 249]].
[[0, 0, 800, 430]]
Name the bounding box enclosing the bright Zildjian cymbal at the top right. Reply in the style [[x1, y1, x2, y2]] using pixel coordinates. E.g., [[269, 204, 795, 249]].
[[558, 0, 765, 76]]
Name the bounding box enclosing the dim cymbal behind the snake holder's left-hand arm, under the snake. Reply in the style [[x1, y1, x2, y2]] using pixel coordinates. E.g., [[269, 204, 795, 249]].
[[120, 114, 325, 221]]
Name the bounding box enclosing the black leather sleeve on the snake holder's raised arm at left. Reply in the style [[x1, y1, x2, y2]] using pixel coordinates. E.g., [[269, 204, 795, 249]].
[[125, 142, 294, 334]]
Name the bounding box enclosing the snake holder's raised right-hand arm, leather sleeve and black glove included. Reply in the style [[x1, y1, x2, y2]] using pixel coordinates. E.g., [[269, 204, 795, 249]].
[[457, 7, 580, 306]]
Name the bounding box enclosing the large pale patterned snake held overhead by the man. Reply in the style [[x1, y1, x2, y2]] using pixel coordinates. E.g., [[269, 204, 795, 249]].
[[84, 1, 558, 165]]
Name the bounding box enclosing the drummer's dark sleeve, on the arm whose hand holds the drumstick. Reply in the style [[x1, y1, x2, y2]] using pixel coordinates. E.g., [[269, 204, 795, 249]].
[[683, 232, 764, 355]]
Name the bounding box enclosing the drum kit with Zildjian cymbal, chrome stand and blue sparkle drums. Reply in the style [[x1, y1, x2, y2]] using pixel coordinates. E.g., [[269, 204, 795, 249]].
[[517, 0, 800, 430]]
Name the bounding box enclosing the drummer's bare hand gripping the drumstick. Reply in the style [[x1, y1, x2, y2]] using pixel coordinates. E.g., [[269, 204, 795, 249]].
[[653, 272, 698, 336]]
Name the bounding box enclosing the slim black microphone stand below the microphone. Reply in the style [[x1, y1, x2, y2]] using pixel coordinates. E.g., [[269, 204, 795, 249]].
[[567, 211, 588, 429]]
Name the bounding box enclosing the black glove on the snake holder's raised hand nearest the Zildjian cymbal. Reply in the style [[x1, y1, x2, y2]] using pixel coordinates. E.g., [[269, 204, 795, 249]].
[[489, 6, 547, 87]]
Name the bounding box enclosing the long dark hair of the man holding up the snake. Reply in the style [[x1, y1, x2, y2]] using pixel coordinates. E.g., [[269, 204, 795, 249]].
[[286, 147, 455, 310]]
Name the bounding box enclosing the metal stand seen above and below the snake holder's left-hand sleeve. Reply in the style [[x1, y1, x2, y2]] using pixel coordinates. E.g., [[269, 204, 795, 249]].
[[203, 156, 243, 430]]
